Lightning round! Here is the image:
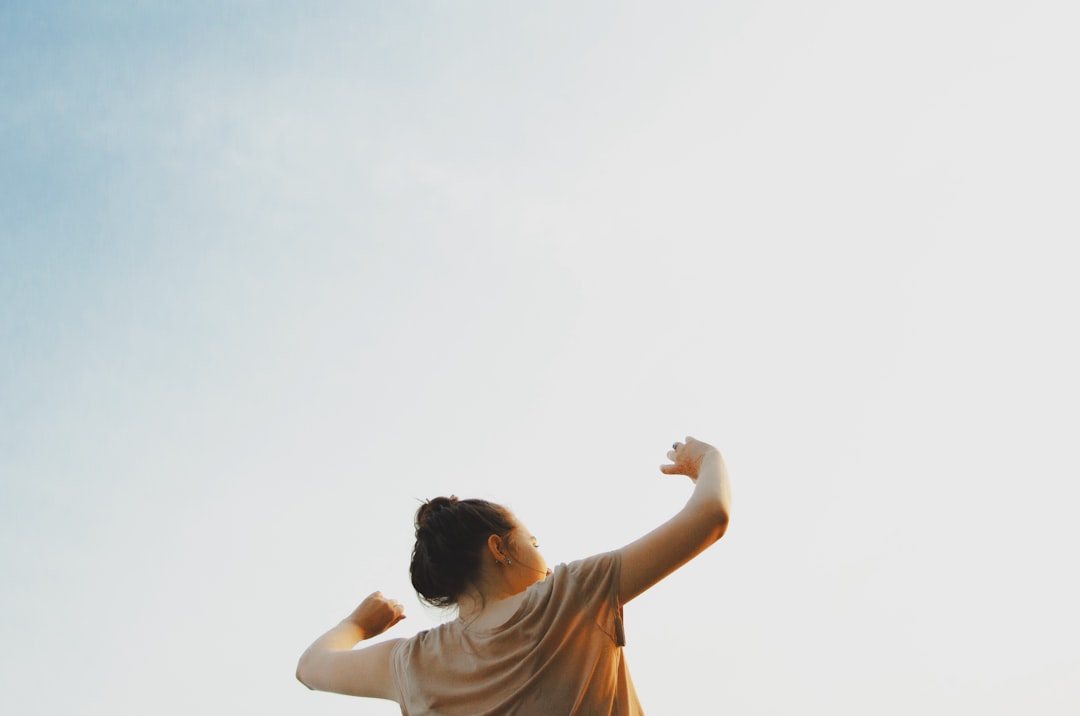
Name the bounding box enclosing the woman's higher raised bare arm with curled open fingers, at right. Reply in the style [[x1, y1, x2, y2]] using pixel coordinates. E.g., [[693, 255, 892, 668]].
[[619, 437, 731, 604]]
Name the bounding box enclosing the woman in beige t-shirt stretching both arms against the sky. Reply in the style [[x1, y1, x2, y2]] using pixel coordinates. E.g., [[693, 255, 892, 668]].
[[296, 437, 731, 716]]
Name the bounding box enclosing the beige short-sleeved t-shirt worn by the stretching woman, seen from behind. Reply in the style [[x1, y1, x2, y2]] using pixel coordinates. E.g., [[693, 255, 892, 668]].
[[390, 552, 643, 716]]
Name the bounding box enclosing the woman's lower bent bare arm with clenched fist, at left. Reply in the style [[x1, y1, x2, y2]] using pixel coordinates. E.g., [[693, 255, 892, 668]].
[[296, 592, 405, 701]]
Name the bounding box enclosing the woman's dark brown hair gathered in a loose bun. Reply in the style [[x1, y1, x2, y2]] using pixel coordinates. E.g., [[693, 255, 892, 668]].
[[408, 495, 514, 607]]
